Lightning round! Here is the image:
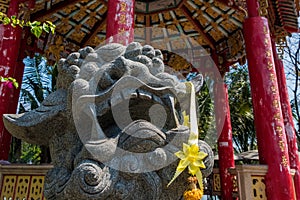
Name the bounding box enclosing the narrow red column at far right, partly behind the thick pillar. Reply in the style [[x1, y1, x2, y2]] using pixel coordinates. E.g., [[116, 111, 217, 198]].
[[272, 39, 300, 199]]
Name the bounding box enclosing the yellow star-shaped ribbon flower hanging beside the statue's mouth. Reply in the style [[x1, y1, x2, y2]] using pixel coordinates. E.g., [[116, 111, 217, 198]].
[[168, 143, 207, 186]]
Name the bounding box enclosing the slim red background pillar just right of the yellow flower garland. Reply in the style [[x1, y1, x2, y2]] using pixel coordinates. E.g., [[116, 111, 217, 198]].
[[214, 80, 235, 200]]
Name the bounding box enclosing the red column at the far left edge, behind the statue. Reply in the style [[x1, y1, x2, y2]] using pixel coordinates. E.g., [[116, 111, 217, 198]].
[[0, 0, 22, 160]]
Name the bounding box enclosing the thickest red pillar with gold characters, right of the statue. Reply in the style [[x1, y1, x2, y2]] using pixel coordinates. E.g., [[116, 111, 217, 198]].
[[244, 17, 295, 200]]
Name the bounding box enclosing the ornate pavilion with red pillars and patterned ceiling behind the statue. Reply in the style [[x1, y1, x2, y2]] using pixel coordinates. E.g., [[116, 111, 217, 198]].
[[0, 0, 300, 200]]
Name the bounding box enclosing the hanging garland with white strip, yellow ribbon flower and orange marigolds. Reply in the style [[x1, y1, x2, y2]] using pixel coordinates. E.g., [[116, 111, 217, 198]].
[[168, 82, 207, 200]]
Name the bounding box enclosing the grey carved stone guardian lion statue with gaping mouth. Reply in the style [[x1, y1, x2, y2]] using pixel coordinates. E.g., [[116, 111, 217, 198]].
[[3, 42, 213, 200]]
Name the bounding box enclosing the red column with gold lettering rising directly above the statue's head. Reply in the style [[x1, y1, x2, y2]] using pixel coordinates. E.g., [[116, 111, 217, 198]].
[[106, 0, 134, 45]]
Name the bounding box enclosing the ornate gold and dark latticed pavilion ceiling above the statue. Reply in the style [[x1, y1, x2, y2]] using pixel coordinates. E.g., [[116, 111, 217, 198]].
[[27, 0, 298, 72]]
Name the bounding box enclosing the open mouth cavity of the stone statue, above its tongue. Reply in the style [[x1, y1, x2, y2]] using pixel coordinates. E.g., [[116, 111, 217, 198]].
[[74, 76, 182, 145]]
